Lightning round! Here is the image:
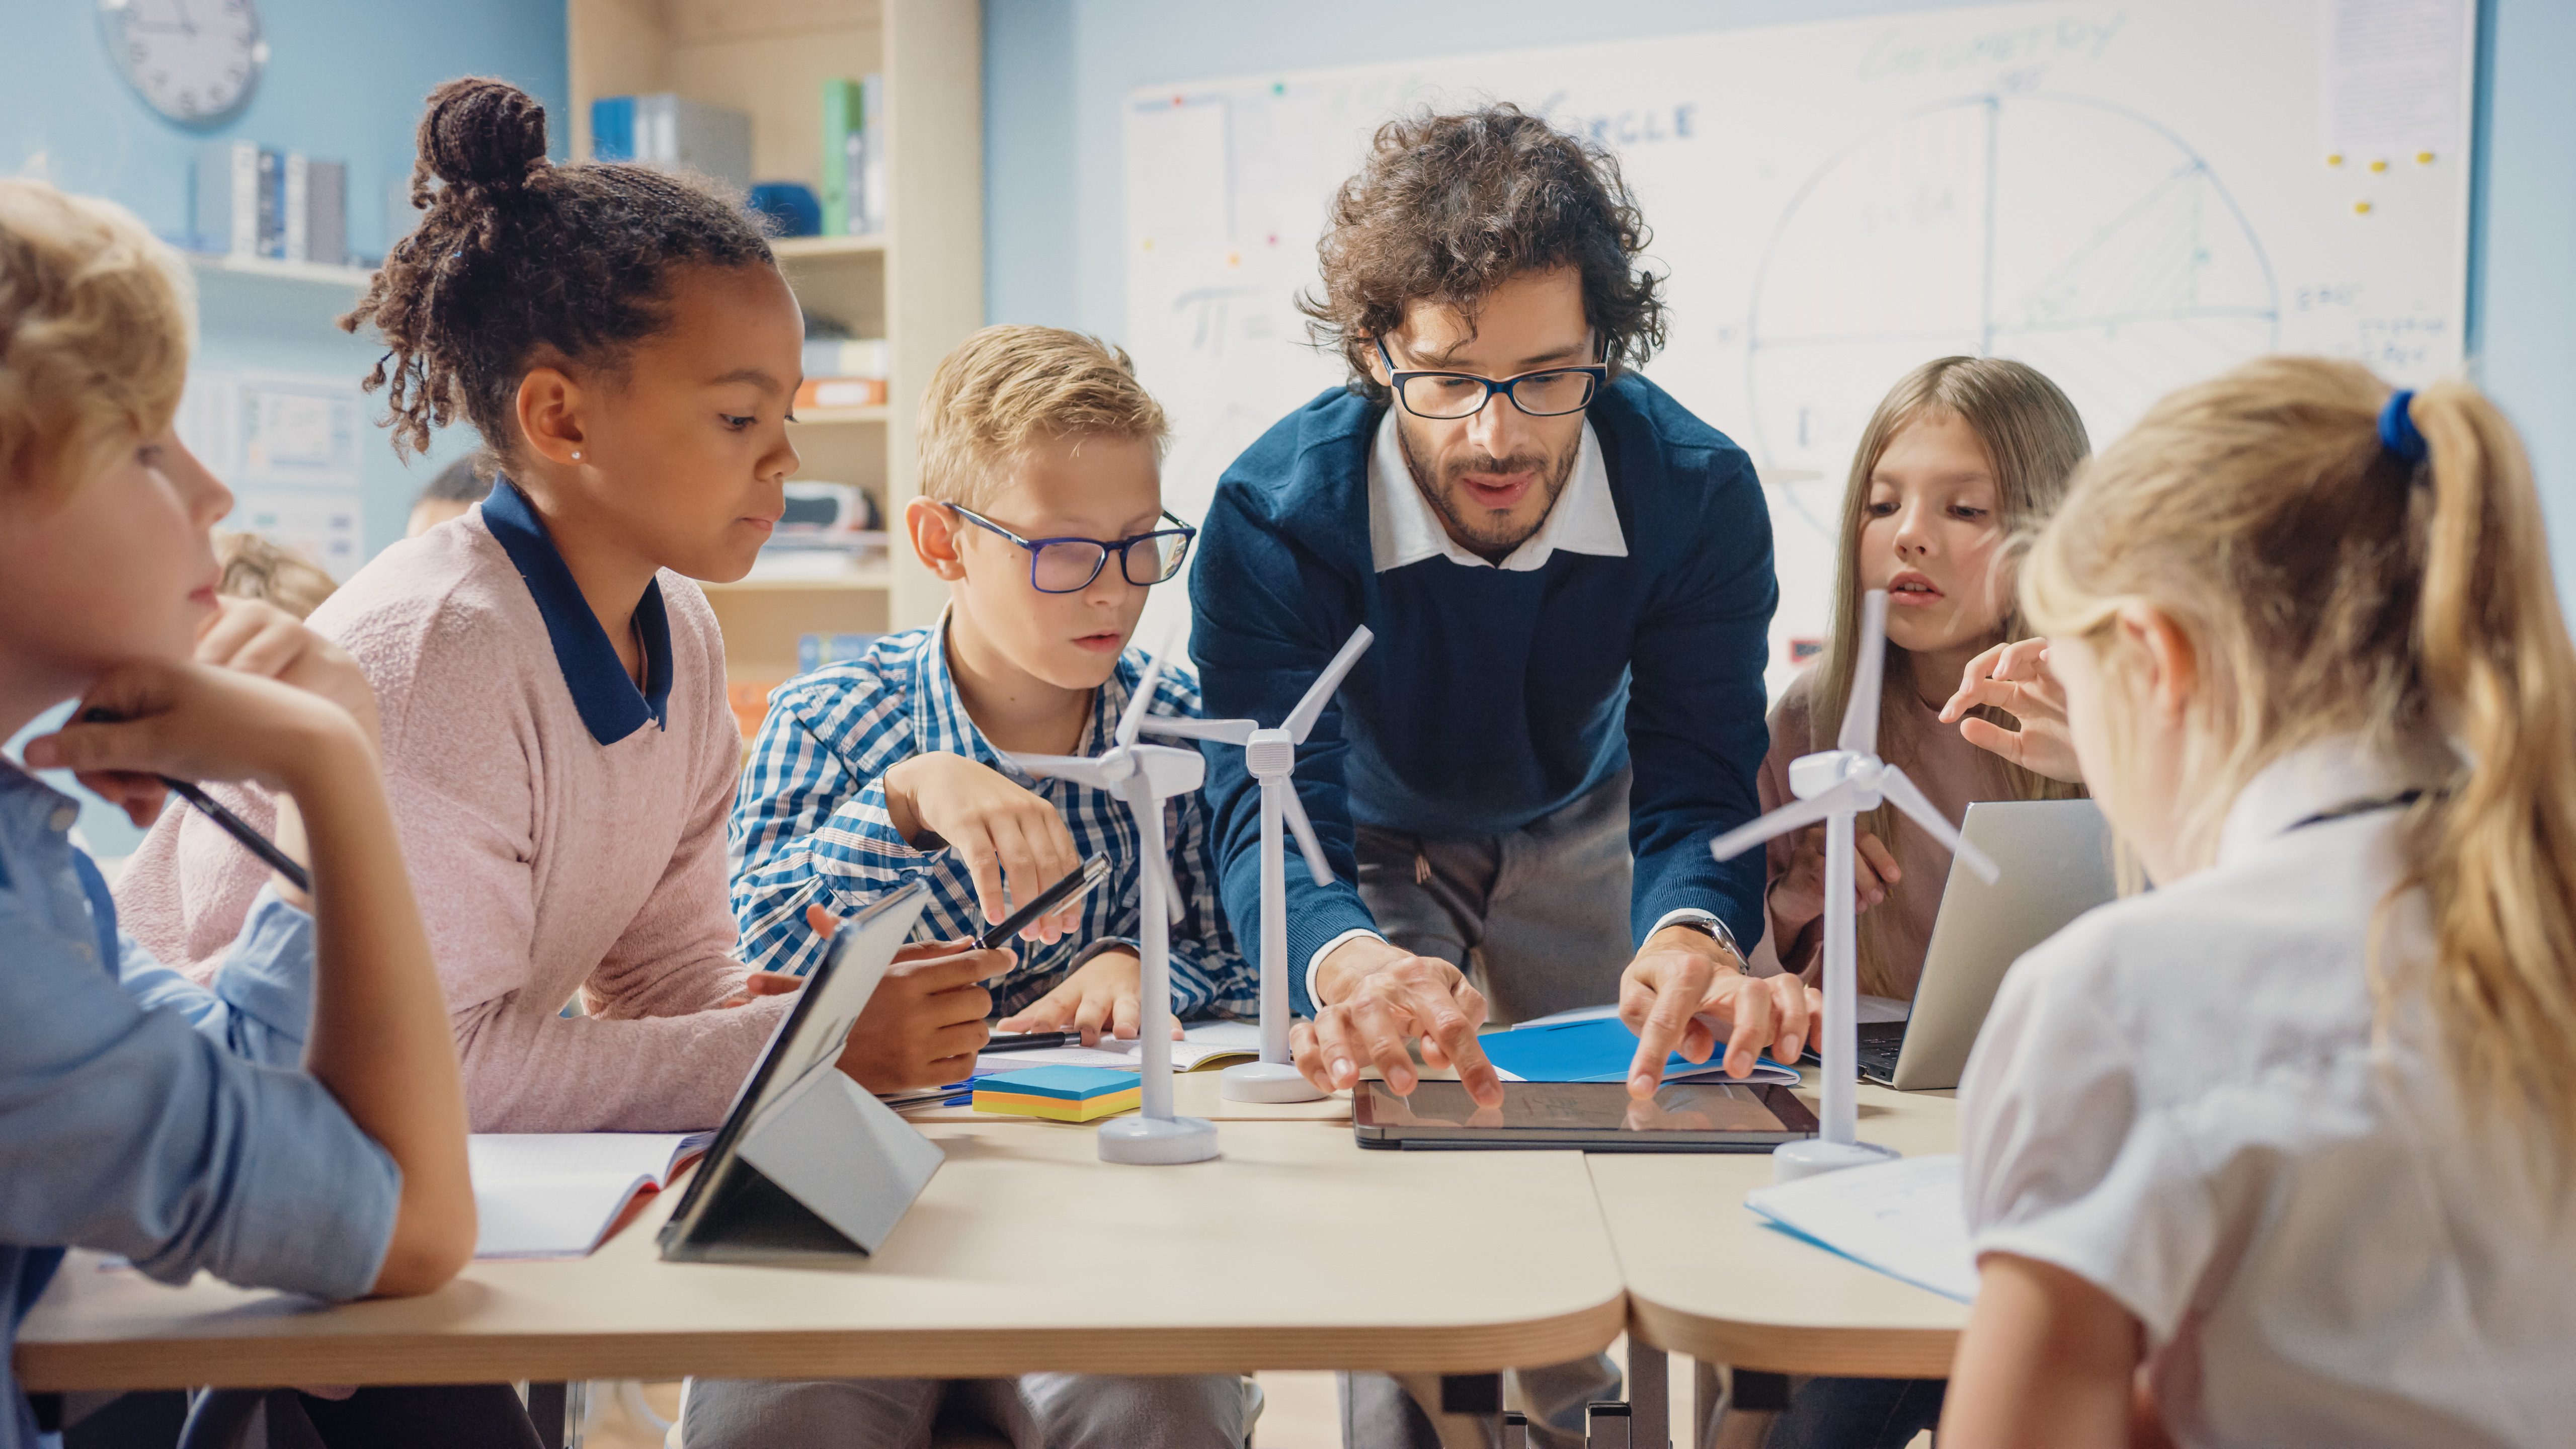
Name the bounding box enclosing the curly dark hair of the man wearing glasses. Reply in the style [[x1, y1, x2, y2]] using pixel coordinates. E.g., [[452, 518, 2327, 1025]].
[[1298, 103, 1664, 402]]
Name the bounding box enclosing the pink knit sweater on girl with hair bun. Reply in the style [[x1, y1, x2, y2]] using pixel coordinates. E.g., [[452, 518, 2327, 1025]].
[[116, 511, 791, 1132]]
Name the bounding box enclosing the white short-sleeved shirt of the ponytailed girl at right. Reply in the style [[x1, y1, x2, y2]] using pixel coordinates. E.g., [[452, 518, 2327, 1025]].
[[1960, 740, 2576, 1449]]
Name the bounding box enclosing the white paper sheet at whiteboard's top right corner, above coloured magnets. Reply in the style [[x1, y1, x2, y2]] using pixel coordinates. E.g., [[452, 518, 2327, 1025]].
[[2326, 0, 2468, 165]]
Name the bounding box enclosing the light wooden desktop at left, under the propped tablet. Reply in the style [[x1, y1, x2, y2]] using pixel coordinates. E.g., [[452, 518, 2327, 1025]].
[[16, 1121, 1628, 1392]]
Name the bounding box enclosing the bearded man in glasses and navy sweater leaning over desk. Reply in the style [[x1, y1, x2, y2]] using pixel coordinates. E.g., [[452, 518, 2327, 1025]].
[[1190, 106, 1821, 1446]]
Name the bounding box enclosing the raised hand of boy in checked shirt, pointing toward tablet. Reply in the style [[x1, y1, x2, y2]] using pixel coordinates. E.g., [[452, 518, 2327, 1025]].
[[886, 750, 1082, 941]]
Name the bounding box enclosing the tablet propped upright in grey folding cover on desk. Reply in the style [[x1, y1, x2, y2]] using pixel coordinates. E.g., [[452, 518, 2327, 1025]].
[[662, 882, 943, 1263]]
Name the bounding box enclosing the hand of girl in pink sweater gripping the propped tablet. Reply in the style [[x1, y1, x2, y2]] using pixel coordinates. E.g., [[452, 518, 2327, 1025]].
[[798, 905, 1012, 1091]]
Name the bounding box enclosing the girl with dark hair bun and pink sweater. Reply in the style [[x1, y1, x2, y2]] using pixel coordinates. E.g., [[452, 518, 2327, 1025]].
[[124, 80, 1010, 1132]]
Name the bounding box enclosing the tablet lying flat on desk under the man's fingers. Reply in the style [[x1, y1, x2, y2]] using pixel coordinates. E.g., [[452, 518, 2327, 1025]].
[[1350, 1080, 1816, 1153]]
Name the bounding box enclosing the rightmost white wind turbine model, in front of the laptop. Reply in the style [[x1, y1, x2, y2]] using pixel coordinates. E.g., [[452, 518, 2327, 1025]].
[[1708, 588, 2001, 1183]]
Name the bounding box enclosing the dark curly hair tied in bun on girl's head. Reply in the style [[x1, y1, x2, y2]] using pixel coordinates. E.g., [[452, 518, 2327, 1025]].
[[340, 77, 775, 459]]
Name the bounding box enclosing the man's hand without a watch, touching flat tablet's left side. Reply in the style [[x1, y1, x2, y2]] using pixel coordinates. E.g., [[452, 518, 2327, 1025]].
[[1288, 936, 1502, 1106]]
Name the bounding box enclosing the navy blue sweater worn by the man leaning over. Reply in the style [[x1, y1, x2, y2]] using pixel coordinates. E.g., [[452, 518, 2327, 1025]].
[[1190, 374, 1778, 1016]]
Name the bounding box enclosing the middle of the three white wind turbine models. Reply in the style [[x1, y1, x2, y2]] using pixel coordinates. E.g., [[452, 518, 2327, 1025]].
[[1144, 624, 1376, 1101]]
